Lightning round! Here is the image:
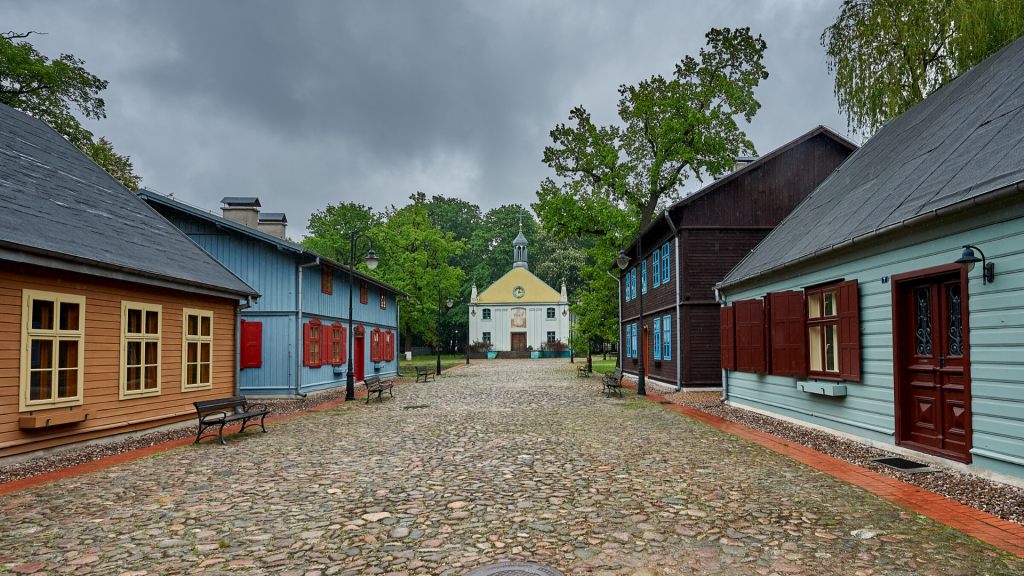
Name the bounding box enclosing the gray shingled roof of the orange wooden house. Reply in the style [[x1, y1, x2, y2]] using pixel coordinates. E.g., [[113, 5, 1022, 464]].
[[0, 105, 259, 297]]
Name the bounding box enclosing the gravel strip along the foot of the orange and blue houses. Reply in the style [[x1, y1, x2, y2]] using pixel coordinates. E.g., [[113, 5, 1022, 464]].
[[0, 379, 415, 484]]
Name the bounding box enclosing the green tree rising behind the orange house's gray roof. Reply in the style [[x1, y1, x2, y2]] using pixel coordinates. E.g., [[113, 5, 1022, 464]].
[[0, 32, 142, 190]]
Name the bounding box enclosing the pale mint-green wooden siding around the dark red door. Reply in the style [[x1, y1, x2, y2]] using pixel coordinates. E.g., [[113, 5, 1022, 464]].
[[727, 202, 1024, 478]]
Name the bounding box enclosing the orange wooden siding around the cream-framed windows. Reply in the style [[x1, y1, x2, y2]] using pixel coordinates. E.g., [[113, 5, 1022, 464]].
[[0, 262, 236, 457]]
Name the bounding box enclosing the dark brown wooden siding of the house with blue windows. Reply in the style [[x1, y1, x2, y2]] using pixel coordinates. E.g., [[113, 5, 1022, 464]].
[[620, 134, 852, 388]]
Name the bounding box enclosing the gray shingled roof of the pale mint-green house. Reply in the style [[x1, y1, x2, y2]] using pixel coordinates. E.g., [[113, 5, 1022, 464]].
[[722, 38, 1024, 285]]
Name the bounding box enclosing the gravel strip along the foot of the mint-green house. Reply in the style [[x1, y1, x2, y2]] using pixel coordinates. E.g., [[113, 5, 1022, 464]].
[[666, 393, 1024, 524]]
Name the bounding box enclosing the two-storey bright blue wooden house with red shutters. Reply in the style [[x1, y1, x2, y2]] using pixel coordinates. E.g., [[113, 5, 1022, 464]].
[[136, 189, 407, 397]]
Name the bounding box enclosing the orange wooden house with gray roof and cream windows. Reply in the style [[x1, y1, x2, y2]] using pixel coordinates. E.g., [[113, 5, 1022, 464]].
[[0, 105, 259, 457]]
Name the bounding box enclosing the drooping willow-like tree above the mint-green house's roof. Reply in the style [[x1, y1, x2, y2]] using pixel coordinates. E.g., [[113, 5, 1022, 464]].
[[821, 0, 1024, 135]]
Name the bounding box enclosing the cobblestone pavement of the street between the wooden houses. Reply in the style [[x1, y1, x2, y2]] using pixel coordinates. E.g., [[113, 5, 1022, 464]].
[[0, 360, 1024, 576]]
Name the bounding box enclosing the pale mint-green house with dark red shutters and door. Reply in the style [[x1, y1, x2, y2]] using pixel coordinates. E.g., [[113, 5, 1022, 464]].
[[717, 39, 1024, 485]]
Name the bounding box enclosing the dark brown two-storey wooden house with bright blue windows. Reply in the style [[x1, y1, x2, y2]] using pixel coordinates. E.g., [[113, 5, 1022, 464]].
[[620, 126, 857, 389]]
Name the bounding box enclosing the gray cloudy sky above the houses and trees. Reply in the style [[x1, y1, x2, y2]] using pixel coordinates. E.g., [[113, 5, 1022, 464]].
[[0, 0, 846, 239]]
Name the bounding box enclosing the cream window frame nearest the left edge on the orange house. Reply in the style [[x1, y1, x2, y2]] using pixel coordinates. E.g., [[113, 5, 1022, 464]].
[[17, 290, 85, 412]]
